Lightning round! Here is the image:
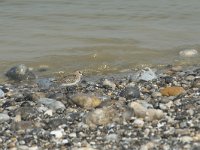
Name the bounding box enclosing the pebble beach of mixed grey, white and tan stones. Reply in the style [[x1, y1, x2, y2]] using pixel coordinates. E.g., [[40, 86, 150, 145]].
[[0, 61, 200, 150]]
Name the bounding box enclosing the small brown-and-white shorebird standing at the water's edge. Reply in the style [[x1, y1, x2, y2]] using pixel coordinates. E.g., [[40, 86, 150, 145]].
[[57, 71, 82, 87]]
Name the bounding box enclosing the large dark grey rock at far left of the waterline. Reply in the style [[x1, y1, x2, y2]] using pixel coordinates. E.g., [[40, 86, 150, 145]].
[[6, 64, 36, 81]]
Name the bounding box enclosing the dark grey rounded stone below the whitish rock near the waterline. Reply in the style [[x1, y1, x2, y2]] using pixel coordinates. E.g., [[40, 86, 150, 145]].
[[120, 86, 140, 99]]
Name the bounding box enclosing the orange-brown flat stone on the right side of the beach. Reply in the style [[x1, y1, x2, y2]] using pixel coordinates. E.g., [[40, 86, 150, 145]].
[[160, 86, 185, 96]]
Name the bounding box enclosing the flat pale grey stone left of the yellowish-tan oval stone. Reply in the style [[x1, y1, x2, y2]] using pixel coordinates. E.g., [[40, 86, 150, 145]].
[[38, 98, 66, 110]]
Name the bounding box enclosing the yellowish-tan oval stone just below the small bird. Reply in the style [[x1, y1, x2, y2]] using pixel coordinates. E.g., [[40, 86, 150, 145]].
[[71, 93, 101, 109]]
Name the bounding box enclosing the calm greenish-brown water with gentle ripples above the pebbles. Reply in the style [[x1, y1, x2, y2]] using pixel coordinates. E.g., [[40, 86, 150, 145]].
[[0, 0, 200, 75]]
